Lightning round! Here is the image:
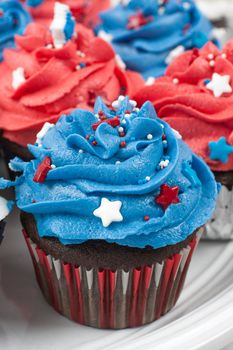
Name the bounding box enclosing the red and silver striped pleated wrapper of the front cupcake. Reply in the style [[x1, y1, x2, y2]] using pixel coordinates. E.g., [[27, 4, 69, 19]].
[[23, 229, 203, 329]]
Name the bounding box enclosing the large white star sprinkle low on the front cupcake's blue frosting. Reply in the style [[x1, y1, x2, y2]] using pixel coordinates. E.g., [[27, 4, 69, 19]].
[[93, 198, 123, 227]]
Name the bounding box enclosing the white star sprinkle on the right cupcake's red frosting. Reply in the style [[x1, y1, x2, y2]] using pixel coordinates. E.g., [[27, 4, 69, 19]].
[[206, 73, 232, 97]]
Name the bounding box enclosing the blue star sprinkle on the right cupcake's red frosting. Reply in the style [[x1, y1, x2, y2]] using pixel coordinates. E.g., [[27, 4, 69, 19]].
[[209, 137, 233, 163]]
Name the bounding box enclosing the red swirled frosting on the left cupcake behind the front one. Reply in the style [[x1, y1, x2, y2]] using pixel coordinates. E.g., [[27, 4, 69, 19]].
[[0, 24, 143, 146]]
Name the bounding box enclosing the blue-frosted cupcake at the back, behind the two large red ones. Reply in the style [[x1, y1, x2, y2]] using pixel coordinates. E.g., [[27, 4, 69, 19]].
[[96, 0, 218, 78]]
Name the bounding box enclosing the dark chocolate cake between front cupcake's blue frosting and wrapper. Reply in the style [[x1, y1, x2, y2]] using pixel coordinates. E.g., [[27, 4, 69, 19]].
[[21, 212, 198, 271]]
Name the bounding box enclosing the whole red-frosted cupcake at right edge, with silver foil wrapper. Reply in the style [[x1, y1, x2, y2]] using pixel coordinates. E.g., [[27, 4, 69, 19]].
[[136, 41, 233, 239]]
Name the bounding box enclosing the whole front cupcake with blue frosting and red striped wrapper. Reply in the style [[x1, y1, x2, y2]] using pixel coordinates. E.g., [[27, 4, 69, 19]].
[[0, 96, 217, 329]]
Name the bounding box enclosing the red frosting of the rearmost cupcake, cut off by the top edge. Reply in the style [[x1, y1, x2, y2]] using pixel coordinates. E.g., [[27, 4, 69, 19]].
[[26, 0, 110, 28]]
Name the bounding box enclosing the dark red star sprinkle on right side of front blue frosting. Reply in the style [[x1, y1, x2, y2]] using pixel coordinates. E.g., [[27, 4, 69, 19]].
[[155, 185, 180, 210]]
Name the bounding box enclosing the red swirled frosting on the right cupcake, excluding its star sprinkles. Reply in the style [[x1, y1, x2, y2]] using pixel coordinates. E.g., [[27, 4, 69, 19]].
[[134, 41, 233, 171]]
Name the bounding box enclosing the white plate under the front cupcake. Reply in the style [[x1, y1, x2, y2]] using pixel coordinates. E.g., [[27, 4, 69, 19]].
[[0, 208, 233, 350]]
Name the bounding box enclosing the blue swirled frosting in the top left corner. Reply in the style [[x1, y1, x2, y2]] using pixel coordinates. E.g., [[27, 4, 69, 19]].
[[0, 0, 31, 61]]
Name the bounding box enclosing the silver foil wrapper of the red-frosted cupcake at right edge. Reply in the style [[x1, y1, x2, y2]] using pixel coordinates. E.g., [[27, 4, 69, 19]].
[[203, 186, 233, 240]]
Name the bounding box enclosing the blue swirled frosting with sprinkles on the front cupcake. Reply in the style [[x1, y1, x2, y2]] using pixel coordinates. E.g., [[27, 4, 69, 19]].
[[0, 97, 217, 248]]
